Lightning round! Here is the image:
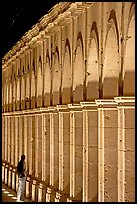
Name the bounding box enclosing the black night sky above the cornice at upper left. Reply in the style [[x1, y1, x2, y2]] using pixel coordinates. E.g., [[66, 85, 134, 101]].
[[0, 0, 59, 57]]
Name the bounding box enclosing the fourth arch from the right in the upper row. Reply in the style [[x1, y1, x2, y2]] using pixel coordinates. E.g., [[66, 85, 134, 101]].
[[73, 33, 85, 103]]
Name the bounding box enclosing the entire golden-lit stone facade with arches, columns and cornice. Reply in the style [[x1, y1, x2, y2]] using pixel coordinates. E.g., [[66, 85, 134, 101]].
[[2, 2, 135, 202]]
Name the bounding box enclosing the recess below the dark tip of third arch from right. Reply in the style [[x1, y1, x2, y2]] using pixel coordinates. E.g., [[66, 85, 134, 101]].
[[86, 38, 99, 101]]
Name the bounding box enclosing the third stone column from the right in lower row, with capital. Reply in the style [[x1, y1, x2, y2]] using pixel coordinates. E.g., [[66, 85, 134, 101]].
[[81, 102, 98, 202]]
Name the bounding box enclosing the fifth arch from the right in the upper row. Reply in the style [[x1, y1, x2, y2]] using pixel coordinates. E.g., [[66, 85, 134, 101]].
[[62, 39, 72, 104]]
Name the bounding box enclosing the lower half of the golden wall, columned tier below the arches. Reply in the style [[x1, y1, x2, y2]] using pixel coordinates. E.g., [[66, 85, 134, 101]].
[[2, 97, 135, 202]]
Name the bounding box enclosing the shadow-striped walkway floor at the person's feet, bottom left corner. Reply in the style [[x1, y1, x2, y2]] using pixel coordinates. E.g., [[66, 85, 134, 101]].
[[2, 183, 32, 203]]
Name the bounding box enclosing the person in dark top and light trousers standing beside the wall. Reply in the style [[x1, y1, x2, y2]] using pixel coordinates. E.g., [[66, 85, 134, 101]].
[[17, 154, 26, 202]]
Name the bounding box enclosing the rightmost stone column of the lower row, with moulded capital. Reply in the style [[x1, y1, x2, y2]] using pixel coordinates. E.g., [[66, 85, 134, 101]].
[[115, 97, 135, 202]]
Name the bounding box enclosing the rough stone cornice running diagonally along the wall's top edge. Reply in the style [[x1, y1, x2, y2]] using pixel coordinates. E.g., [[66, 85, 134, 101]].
[[2, 2, 93, 66]]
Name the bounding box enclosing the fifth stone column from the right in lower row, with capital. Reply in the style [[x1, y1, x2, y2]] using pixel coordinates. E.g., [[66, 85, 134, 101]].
[[57, 105, 70, 200]]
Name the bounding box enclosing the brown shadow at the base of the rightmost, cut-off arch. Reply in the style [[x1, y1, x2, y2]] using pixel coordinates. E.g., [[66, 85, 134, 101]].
[[123, 71, 135, 96]]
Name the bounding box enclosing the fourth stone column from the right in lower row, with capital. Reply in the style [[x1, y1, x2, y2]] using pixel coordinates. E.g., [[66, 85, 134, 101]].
[[69, 104, 83, 201]]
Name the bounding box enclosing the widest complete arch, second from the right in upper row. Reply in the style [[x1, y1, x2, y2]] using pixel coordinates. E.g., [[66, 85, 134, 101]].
[[102, 11, 119, 98]]
